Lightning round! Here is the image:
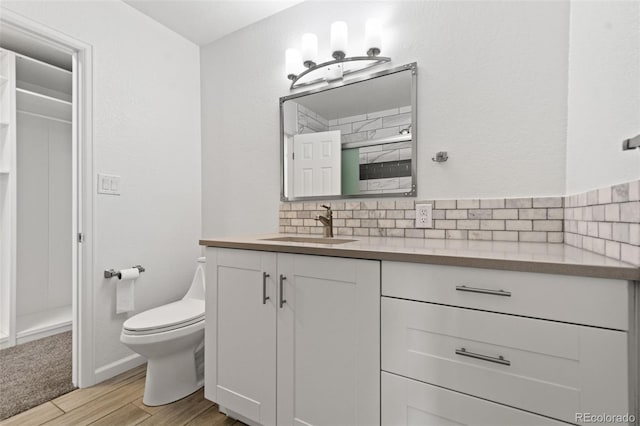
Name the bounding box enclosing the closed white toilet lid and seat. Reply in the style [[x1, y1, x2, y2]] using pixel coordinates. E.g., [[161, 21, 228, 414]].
[[123, 299, 204, 334]]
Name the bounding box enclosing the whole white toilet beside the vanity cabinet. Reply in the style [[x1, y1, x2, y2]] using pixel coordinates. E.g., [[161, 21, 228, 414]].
[[120, 257, 205, 406]]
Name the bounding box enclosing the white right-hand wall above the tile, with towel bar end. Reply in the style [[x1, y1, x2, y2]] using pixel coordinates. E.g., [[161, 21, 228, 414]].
[[567, 1, 640, 194]]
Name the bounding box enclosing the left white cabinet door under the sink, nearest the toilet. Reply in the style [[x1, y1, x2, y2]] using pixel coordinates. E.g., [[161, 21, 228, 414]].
[[205, 248, 276, 426]]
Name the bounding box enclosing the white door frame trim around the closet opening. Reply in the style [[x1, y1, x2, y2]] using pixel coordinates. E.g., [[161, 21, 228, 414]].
[[0, 8, 95, 388]]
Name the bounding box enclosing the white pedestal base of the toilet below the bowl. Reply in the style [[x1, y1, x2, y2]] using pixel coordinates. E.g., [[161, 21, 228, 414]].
[[142, 349, 203, 407]]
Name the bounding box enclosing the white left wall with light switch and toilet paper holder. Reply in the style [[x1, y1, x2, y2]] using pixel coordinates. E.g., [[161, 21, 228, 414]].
[[2, 1, 201, 378]]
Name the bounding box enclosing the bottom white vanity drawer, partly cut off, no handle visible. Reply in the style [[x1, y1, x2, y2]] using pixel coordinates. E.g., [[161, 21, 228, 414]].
[[382, 372, 566, 426]]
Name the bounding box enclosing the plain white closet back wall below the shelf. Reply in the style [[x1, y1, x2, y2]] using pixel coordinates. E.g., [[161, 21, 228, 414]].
[[16, 113, 73, 318]]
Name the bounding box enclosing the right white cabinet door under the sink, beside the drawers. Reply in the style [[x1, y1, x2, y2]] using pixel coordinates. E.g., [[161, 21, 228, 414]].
[[277, 254, 380, 426]]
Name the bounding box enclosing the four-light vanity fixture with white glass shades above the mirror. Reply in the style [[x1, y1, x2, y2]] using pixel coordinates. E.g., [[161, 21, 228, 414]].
[[285, 19, 391, 89]]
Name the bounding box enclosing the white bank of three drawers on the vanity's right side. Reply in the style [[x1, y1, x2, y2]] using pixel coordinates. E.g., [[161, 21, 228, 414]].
[[381, 261, 634, 425]]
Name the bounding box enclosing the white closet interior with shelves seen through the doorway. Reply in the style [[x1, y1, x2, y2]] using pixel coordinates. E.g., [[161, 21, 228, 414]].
[[0, 46, 73, 348]]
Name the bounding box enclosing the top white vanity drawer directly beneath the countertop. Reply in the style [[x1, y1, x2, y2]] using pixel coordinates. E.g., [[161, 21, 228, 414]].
[[382, 261, 629, 330]]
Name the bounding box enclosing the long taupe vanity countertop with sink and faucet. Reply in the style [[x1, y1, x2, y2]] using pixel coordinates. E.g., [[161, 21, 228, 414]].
[[200, 234, 640, 281]]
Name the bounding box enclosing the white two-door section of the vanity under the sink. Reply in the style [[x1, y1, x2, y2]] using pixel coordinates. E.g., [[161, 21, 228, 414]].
[[205, 247, 380, 426]]
